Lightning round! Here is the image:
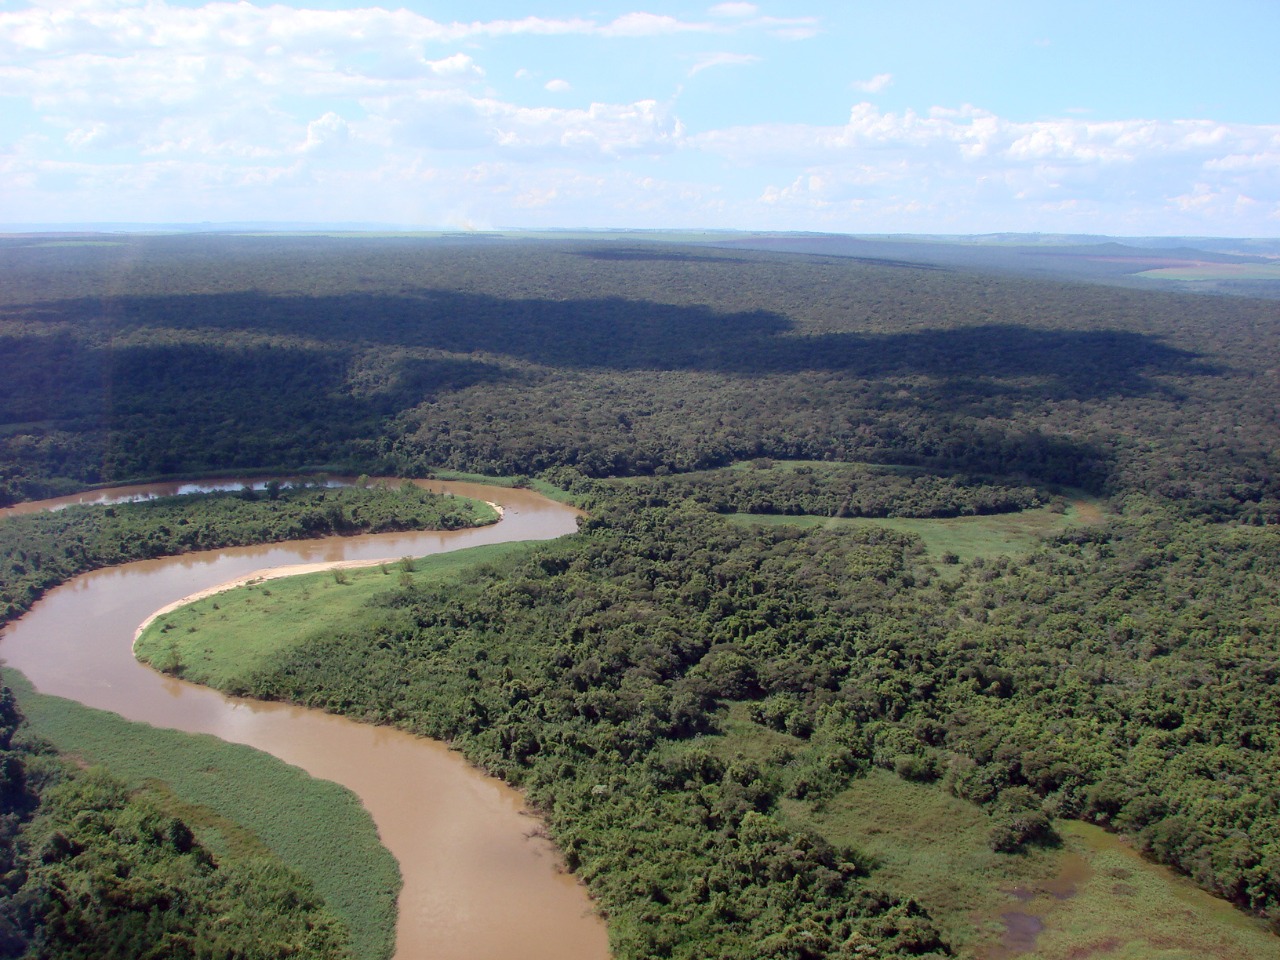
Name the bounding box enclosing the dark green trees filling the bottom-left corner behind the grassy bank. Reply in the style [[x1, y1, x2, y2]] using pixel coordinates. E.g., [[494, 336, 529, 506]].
[[0, 687, 351, 960]]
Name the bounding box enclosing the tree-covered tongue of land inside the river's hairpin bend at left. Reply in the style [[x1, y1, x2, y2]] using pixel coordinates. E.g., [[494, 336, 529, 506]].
[[0, 481, 497, 623]]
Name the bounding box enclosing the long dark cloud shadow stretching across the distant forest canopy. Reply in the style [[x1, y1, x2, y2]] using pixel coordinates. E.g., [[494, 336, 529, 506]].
[[10, 291, 1219, 399]]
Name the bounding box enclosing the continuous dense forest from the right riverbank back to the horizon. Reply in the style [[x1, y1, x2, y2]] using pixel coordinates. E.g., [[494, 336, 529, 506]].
[[0, 236, 1280, 957]]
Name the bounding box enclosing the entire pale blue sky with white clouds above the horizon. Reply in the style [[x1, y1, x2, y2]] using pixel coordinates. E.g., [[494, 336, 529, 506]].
[[0, 0, 1280, 237]]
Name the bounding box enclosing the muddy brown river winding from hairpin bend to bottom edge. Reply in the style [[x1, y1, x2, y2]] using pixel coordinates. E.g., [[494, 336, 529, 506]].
[[0, 483, 608, 960]]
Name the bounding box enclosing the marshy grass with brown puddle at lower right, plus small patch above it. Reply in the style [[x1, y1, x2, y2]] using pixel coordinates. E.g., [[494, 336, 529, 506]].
[[703, 704, 1280, 960]]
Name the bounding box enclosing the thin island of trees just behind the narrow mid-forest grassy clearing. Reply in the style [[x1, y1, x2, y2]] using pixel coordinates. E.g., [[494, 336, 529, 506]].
[[622, 458, 1052, 517]]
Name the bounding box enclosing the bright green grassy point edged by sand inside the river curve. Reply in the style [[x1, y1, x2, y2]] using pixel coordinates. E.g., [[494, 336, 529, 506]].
[[134, 543, 529, 691]]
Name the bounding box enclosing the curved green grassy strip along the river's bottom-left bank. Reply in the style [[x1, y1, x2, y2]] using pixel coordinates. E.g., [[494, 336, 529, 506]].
[[4, 669, 399, 960]]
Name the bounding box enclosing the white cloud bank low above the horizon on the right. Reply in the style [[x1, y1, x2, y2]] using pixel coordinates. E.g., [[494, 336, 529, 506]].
[[687, 104, 1280, 233]]
